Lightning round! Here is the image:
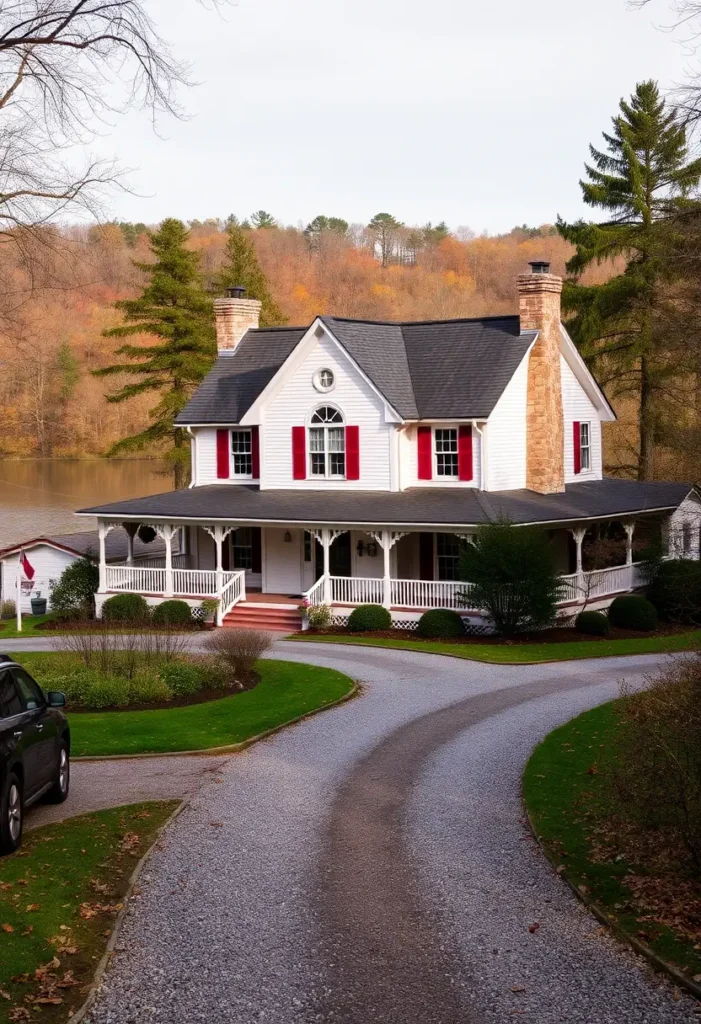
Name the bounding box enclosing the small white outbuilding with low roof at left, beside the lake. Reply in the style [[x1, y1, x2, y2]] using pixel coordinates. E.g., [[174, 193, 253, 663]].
[[0, 529, 173, 614]]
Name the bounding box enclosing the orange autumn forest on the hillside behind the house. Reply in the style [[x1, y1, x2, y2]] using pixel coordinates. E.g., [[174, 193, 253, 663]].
[[0, 211, 630, 468]]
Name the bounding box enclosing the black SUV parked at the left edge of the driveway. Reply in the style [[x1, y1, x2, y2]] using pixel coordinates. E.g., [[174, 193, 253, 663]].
[[0, 654, 71, 854]]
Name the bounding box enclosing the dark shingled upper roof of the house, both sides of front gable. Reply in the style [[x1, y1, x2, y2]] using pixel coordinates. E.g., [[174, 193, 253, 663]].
[[176, 316, 535, 424]]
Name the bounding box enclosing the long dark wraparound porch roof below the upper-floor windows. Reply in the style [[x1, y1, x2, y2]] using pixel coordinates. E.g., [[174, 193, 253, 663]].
[[78, 478, 691, 527]]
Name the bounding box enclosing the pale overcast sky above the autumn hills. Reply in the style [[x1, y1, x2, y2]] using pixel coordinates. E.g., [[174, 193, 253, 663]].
[[99, 0, 688, 232]]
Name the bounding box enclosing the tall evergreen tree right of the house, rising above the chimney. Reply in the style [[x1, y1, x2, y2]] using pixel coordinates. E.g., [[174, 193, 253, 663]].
[[558, 82, 701, 480]]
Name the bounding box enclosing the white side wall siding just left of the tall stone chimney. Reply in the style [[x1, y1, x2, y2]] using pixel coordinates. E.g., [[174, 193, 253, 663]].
[[484, 355, 529, 490]]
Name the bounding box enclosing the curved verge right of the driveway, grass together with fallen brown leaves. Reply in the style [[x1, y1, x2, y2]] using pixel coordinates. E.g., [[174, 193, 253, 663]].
[[523, 701, 701, 991]]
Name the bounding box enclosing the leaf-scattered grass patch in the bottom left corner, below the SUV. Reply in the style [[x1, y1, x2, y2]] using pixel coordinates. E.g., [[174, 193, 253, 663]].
[[0, 801, 178, 1024]]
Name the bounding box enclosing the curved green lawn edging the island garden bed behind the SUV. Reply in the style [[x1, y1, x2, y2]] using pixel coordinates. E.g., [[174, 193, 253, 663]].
[[16, 651, 353, 757]]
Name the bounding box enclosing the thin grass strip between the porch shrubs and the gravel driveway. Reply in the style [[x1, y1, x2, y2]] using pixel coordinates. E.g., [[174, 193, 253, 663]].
[[289, 630, 701, 665]]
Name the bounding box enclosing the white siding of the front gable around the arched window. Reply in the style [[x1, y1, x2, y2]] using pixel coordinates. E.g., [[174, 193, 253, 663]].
[[260, 337, 394, 490]]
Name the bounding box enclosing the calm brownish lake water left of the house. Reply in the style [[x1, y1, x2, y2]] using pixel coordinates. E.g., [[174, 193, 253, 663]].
[[0, 459, 173, 549]]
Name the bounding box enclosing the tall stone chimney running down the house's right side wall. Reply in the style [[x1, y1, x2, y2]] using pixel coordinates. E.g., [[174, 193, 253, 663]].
[[518, 262, 565, 495]]
